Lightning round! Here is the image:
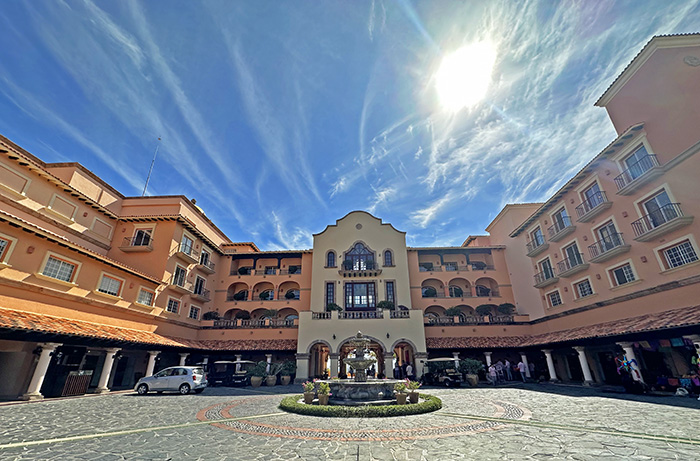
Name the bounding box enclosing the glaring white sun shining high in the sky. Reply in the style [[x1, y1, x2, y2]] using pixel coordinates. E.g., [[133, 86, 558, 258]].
[[435, 41, 496, 112]]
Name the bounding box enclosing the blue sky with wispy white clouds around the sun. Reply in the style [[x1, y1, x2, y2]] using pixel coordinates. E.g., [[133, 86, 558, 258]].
[[0, 0, 700, 250]]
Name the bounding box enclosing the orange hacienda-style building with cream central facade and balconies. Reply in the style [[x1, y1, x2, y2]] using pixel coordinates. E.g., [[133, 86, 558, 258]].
[[0, 34, 700, 399]]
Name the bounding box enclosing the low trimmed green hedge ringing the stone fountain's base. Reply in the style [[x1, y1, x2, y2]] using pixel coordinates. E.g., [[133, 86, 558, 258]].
[[279, 394, 442, 418]]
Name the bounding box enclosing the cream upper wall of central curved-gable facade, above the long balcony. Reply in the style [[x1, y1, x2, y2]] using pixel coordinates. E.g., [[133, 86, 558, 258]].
[[311, 211, 411, 312]]
